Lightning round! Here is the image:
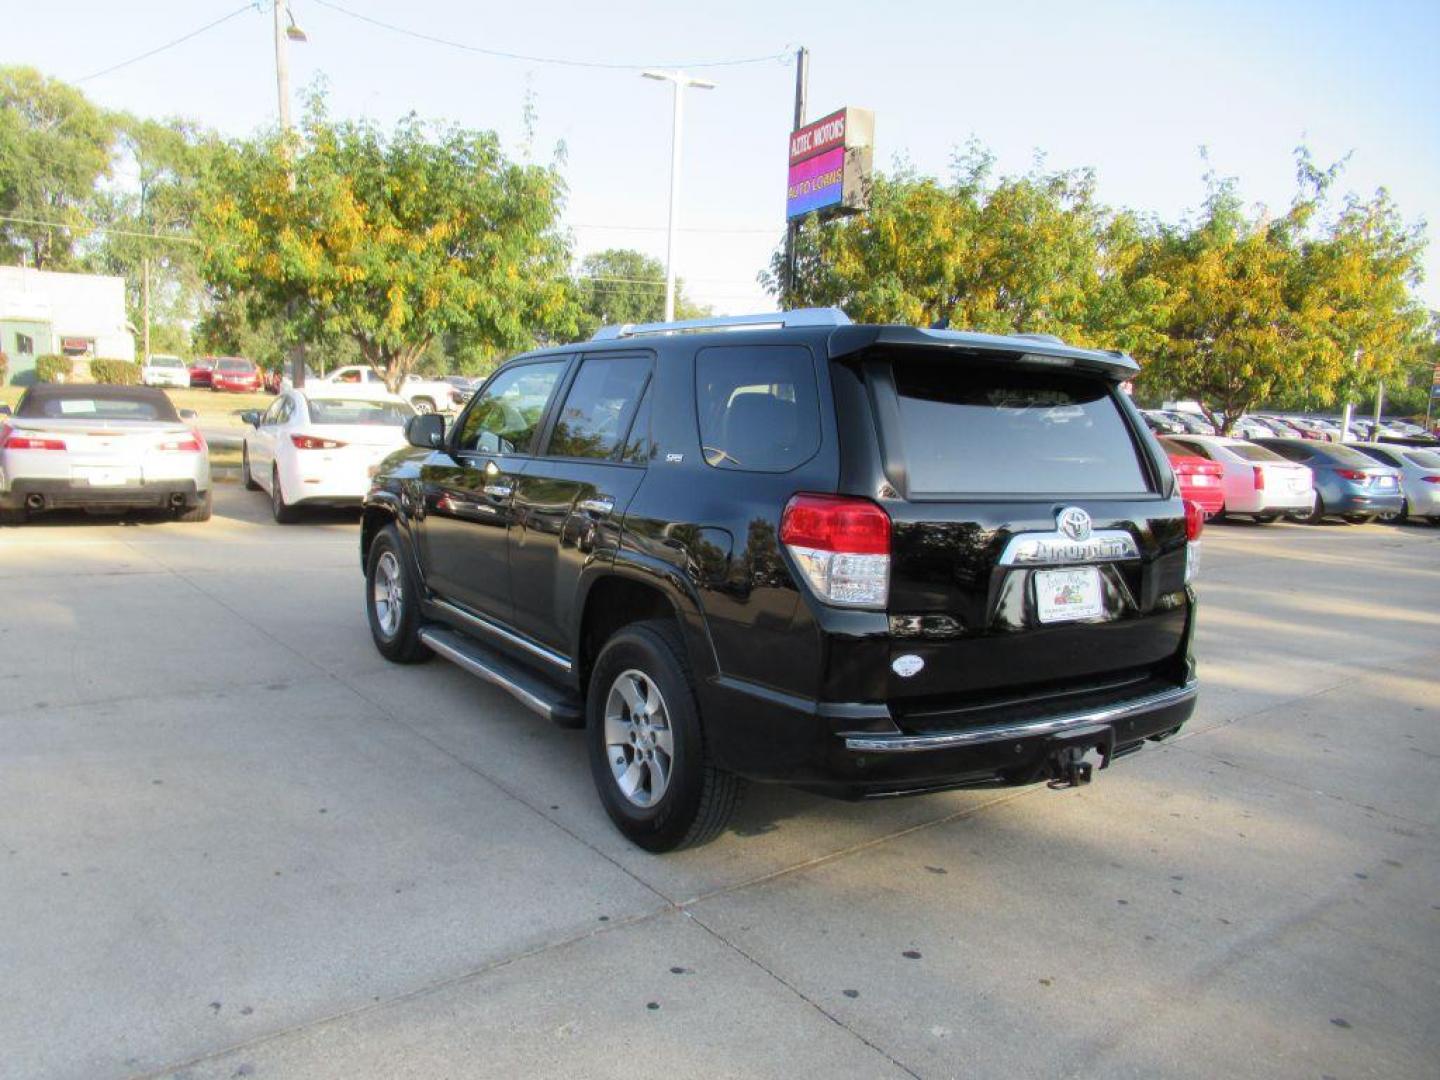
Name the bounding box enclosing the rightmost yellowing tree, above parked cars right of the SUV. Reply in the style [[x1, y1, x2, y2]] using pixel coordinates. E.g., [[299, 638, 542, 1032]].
[[1140, 154, 1426, 431]]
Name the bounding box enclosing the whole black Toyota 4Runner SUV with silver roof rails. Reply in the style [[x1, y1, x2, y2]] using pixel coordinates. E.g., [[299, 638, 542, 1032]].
[[360, 310, 1200, 851]]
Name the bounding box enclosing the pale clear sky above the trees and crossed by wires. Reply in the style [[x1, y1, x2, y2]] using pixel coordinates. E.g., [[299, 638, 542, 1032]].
[[0, 0, 1440, 312]]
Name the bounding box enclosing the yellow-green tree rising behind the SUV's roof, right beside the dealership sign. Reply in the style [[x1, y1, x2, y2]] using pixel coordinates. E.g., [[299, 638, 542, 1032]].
[[762, 143, 1165, 348]]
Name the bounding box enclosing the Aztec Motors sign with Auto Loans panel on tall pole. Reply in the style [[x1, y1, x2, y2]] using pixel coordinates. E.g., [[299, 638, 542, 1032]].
[[785, 108, 876, 219]]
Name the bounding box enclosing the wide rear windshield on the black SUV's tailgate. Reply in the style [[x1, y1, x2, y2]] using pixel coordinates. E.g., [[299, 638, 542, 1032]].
[[887, 364, 1151, 495]]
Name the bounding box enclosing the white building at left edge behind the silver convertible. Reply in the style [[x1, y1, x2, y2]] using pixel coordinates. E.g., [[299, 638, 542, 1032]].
[[0, 266, 135, 384]]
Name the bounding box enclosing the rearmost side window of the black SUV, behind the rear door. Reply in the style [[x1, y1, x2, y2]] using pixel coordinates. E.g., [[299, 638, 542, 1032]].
[[696, 346, 819, 472]]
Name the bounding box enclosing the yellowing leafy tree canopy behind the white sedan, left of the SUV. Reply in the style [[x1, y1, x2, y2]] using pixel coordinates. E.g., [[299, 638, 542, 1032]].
[[199, 96, 580, 389]]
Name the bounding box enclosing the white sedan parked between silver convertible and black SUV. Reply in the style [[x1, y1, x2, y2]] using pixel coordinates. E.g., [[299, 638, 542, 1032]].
[[240, 386, 415, 524]]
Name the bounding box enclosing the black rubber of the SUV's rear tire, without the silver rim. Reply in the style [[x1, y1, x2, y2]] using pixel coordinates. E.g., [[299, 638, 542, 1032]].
[[585, 621, 744, 851]]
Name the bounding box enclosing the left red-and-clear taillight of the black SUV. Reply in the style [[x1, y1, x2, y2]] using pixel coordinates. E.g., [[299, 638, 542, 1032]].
[[780, 495, 890, 608]]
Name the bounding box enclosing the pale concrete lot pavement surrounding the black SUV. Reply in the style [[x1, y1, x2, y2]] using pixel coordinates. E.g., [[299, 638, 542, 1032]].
[[0, 485, 1440, 1079]]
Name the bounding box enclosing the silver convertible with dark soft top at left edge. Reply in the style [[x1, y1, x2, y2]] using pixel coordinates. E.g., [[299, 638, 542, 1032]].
[[0, 383, 212, 524]]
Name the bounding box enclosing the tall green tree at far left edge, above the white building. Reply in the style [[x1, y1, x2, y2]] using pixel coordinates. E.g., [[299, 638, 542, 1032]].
[[0, 68, 115, 269]]
